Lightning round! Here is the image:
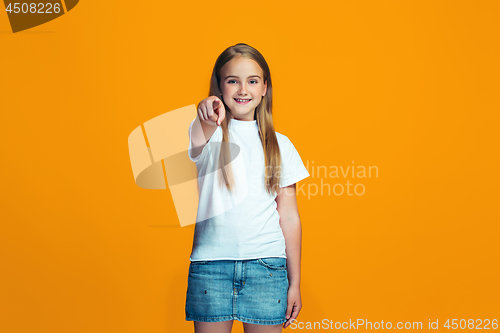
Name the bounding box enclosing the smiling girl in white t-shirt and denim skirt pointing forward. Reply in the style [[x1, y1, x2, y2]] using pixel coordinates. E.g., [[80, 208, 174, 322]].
[[186, 43, 309, 333]]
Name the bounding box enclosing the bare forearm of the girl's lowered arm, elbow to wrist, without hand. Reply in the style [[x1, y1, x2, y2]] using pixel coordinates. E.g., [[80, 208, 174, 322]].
[[280, 218, 302, 287]]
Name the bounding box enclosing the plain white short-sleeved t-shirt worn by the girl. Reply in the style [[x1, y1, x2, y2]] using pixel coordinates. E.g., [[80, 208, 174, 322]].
[[188, 118, 309, 261]]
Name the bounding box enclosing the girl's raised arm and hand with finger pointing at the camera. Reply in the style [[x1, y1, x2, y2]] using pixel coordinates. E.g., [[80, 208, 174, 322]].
[[191, 96, 226, 158]]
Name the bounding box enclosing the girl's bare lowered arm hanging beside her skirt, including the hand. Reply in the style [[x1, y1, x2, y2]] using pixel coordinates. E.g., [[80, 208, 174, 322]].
[[276, 184, 302, 328]]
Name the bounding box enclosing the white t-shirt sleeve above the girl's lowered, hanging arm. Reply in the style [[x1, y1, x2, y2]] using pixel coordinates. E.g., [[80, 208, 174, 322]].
[[280, 137, 310, 187]]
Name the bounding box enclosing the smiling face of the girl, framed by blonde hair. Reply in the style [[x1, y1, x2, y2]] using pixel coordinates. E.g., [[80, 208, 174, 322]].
[[220, 56, 267, 121]]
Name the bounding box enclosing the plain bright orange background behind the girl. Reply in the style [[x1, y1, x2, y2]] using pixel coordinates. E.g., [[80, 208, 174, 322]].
[[0, 0, 500, 333]]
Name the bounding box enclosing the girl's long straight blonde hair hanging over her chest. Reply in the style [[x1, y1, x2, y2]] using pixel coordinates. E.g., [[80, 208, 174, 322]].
[[204, 43, 281, 194]]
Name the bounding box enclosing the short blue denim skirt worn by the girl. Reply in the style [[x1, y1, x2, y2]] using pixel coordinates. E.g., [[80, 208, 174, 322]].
[[186, 257, 289, 325]]
